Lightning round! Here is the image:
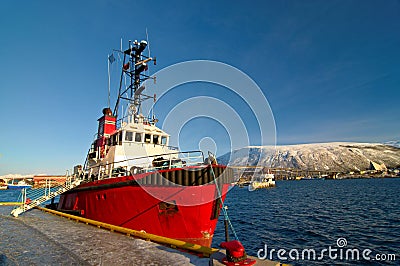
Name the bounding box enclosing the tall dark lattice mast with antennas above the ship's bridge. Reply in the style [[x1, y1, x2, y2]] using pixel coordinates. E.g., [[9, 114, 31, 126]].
[[113, 40, 156, 123]]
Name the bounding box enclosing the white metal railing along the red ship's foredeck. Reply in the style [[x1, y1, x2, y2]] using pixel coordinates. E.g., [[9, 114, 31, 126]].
[[84, 151, 204, 180]]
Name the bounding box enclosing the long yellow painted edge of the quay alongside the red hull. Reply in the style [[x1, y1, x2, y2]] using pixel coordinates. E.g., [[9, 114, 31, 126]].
[[36, 207, 219, 257]]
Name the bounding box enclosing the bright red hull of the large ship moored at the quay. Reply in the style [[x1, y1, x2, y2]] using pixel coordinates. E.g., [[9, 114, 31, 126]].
[[58, 166, 229, 247]]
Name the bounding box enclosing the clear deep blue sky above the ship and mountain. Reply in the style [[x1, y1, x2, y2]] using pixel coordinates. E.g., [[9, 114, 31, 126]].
[[0, 0, 400, 175]]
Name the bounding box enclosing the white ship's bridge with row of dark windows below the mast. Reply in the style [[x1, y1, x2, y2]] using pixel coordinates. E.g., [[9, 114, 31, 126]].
[[88, 111, 179, 177]]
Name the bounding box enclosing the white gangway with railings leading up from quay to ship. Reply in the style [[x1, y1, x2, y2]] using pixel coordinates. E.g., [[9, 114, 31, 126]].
[[11, 176, 82, 217]]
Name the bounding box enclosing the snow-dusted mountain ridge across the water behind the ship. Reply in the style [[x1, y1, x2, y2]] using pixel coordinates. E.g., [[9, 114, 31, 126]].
[[218, 142, 400, 171]]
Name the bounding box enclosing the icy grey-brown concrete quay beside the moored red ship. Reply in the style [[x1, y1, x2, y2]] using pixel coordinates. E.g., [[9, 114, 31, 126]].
[[0, 206, 283, 266]]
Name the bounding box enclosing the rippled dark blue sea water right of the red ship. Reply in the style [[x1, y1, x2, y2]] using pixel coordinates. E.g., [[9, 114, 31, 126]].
[[213, 178, 400, 265]]
